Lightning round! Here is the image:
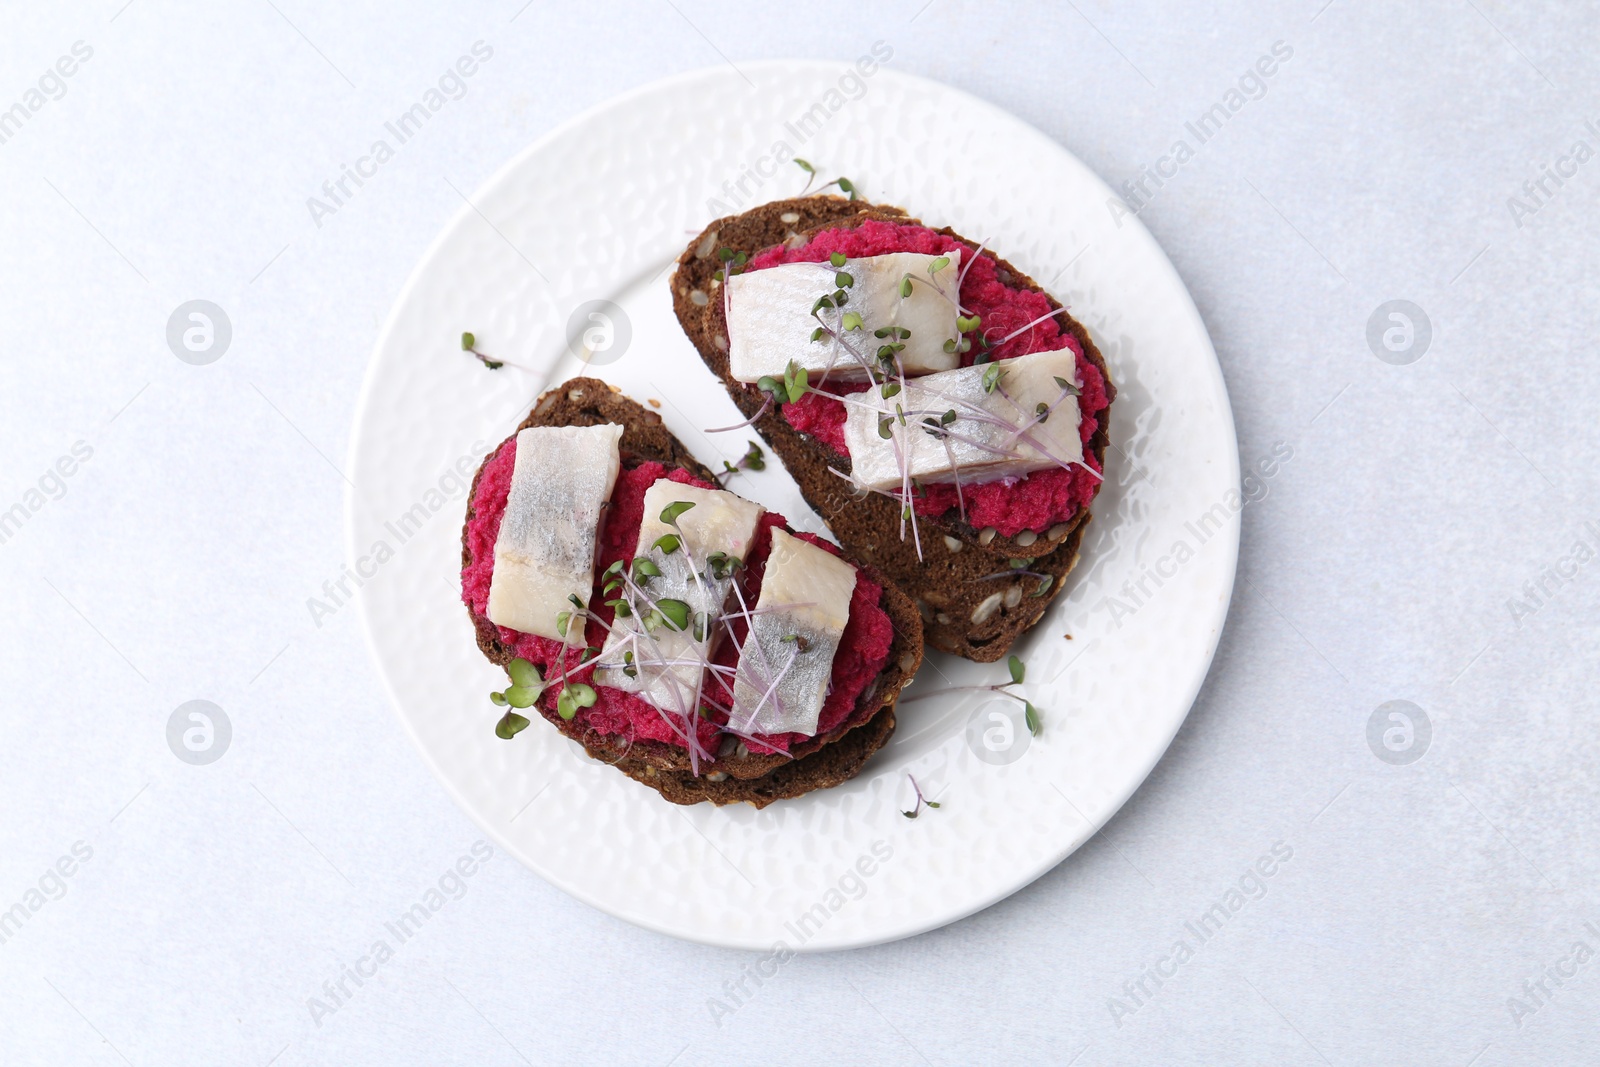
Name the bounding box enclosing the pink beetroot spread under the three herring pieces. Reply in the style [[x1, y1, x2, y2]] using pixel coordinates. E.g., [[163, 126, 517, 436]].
[[461, 437, 894, 764]]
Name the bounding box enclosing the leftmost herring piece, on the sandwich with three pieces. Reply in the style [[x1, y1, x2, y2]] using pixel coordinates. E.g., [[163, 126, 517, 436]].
[[485, 422, 622, 645]]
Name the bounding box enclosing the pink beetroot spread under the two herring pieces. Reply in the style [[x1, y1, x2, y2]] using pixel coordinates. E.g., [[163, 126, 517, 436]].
[[746, 221, 1109, 537]]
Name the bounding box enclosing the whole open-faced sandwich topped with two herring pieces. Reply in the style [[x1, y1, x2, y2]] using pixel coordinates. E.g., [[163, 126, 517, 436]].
[[672, 195, 1115, 662]]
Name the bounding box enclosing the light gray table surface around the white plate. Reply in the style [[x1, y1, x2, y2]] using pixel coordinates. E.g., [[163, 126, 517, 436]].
[[0, 0, 1600, 1067]]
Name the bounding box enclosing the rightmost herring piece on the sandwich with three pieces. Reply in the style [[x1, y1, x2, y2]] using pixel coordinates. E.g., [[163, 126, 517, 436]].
[[728, 530, 856, 737]]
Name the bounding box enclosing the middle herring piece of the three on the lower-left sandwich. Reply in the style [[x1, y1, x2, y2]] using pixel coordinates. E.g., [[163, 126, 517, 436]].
[[595, 478, 766, 715]]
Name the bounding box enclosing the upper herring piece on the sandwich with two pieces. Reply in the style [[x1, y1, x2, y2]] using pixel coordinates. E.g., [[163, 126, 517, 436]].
[[728, 250, 962, 384]]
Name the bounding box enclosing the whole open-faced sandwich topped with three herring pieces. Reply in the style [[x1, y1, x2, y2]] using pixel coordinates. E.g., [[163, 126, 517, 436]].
[[461, 378, 922, 808]]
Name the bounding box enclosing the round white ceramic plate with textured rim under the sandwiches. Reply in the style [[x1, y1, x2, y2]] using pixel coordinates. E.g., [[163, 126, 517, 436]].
[[347, 62, 1238, 950]]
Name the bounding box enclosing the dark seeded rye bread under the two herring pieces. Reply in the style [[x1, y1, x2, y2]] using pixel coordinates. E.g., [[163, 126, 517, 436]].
[[670, 197, 1114, 662]]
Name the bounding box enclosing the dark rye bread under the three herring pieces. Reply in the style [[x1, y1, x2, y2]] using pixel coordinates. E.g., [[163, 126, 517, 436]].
[[461, 378, 922, 808]]
